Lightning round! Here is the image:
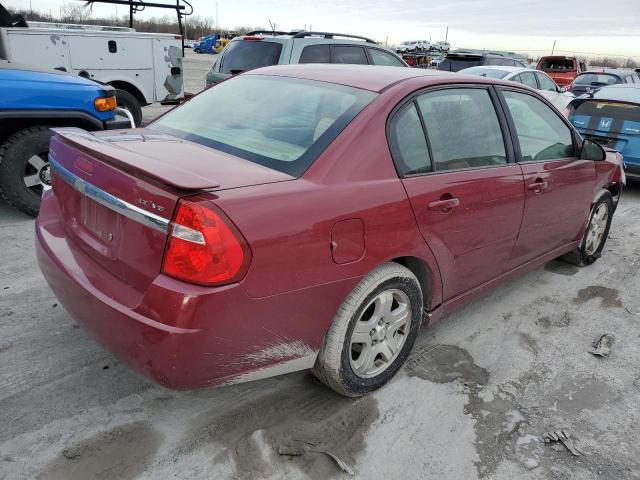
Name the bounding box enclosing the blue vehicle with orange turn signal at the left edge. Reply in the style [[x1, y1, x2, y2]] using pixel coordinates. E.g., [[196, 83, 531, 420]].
[[0, 60, 131, 216]]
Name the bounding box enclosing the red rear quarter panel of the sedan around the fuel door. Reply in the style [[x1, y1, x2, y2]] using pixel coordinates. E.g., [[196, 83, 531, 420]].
[[216, 87, 441, 304]]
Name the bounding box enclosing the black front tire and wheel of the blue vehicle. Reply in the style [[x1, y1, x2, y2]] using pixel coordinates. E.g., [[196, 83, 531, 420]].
[[0, 125, 51, 217]]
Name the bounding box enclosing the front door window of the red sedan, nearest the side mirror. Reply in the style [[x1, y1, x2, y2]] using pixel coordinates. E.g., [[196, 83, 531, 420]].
[[503, 91, 574, 162]]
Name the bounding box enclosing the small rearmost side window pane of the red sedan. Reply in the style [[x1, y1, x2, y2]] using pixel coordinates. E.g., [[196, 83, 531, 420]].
[[391, 102, 431, 175]]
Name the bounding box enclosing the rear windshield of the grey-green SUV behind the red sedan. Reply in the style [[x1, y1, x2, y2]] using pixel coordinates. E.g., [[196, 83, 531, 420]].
[[219, 40, 282, 74]]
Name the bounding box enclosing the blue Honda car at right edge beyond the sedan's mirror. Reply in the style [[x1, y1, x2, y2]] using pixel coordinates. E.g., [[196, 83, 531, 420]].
[[569, 83, 640, 180]]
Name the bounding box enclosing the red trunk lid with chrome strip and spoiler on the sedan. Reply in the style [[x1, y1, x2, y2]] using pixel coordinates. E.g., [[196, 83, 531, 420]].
[[50, 129, 294, 291]]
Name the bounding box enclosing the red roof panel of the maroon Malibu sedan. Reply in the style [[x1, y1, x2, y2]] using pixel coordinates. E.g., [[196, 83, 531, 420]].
[[242, 63, 509, 92]]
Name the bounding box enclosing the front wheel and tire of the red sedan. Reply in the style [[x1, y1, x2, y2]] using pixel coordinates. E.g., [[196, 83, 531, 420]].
[[561, 192, 615, 267]]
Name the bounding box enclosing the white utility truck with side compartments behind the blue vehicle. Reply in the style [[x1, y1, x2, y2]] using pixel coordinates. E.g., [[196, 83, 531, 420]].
[[0, 22, 184, 126]]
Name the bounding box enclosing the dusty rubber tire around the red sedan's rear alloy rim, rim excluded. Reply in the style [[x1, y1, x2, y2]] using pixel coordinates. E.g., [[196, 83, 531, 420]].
[[313, 262, 423, 397]]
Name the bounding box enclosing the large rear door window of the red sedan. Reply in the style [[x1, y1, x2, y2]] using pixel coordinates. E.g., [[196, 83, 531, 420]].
[[417, 88, 507, 171]]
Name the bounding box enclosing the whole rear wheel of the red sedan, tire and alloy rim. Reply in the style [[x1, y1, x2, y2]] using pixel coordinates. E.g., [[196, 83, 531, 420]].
[[313, 262, 423, 397]]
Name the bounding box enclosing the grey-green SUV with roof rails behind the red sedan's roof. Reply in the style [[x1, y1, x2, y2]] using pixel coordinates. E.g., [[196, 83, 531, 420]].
[[206, 31, 408, 87]]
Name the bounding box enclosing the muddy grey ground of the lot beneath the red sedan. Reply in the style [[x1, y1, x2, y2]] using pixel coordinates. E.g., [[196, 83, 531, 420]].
[[0, 52, 640, 480]]
